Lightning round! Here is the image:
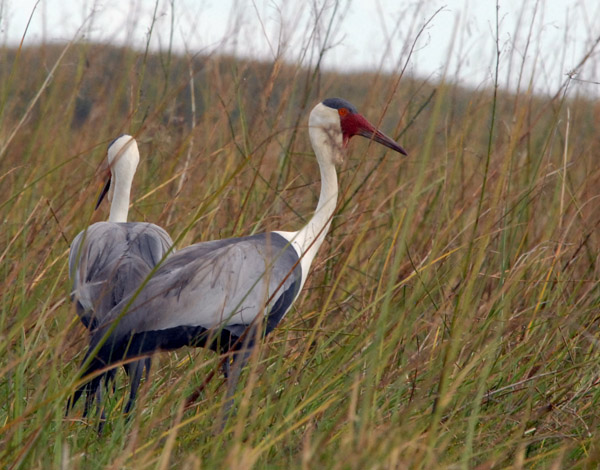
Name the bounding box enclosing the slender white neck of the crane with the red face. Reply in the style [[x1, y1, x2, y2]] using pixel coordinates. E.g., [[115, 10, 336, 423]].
[[277, 120, 341, 289]]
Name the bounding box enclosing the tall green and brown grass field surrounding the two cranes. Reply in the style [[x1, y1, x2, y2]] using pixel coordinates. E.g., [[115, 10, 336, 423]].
[[0, 5, 600, 470]]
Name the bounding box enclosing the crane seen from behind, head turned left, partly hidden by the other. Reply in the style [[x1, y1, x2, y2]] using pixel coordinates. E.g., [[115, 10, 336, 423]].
[[69, 135, 173, 411]]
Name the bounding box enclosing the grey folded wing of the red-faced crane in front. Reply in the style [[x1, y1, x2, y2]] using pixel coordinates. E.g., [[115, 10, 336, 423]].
[[101, 233, 302, 342]]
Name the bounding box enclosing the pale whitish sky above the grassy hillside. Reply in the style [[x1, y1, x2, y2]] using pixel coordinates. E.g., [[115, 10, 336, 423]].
[[0, 0, 600, 96]]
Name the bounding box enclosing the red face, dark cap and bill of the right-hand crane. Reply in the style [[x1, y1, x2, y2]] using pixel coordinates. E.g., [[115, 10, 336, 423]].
[[321, 98, 407, 155]]
